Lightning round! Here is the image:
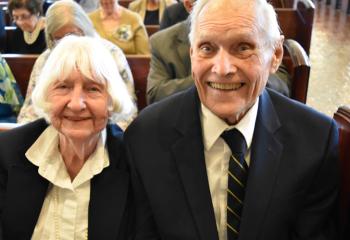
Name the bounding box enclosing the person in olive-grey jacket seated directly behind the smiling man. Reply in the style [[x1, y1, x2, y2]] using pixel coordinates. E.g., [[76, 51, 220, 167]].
[[147, 0, 290, 104]]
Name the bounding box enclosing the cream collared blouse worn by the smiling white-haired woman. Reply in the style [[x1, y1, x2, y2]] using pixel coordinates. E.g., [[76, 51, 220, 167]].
[[25, 126, 109, 240]]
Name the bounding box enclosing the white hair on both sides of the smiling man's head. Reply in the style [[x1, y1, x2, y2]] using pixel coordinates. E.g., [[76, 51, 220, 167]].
[[189, 0, 281, 49]]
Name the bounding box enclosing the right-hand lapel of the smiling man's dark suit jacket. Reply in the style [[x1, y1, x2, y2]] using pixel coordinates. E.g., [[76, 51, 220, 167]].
[[239, 90, 283, 240]]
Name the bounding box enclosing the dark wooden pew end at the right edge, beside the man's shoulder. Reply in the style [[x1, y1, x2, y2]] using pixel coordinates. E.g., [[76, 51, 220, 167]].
[[333, 106, 350, 240]]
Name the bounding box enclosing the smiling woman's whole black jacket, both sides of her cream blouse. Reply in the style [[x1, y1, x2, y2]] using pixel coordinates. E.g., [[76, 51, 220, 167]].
[[0, 119, 132, 240]]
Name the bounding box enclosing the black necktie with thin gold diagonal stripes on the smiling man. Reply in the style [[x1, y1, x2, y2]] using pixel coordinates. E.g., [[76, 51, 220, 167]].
[[221, 129, 248, 240]]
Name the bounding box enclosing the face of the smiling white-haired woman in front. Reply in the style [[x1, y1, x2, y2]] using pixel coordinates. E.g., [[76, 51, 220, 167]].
[[48, 70, 110, 141]]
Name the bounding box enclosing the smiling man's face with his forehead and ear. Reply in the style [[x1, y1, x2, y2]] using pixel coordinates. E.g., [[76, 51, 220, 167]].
[[191, 0, 278, 124]]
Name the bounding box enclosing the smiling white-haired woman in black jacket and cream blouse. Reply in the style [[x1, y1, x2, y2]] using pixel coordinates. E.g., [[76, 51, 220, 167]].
[[0, 36, 133, 240]]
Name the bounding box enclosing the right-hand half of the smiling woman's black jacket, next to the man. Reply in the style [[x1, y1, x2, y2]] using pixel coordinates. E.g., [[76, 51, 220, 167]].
[[89, 126, 129, 240]]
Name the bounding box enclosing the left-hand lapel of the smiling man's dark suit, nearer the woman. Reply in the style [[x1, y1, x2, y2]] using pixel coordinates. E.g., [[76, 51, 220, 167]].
[[172, 88, 218, 240]]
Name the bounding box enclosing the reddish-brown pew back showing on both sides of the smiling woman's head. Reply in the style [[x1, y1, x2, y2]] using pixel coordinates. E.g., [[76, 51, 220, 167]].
[[2, 54, 150, 110]]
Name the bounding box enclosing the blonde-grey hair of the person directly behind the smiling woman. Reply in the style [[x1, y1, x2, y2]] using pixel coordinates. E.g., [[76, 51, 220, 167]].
[[45, 0, 98, 49]]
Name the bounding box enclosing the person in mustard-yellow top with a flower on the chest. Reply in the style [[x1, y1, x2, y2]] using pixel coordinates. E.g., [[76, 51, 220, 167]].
[[89, 0, 150, 54]]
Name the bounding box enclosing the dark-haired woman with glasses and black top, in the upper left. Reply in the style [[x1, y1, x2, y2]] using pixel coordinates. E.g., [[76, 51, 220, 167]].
[[6, 0, 46, 53]]
